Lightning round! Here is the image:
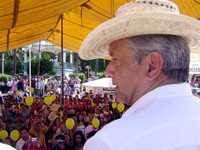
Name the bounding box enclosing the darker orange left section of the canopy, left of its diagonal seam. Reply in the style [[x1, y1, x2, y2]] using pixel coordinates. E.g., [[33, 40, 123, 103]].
[[0, 0, 87, 51]]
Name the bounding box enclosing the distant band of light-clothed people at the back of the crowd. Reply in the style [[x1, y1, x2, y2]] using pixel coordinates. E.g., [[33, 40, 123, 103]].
[[0, 76, 81, 97]]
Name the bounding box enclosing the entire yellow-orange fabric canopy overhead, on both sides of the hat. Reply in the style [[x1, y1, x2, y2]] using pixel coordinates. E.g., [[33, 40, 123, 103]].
[[0, 0, 200, 51]]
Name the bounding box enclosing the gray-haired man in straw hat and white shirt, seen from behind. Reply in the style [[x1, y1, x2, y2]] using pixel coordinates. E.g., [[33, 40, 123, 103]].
[[80, 0, 200, 150]]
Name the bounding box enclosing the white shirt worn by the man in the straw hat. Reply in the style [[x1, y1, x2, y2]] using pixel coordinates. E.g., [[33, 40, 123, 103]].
[[84, 83, 200, 150]]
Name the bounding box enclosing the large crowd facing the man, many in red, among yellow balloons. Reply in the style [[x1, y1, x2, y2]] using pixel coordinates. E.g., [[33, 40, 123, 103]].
[[0, 78, 125, 150]]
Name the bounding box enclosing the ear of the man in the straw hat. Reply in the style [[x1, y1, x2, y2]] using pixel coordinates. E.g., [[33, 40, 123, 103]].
[[145, 52, 164, 80]]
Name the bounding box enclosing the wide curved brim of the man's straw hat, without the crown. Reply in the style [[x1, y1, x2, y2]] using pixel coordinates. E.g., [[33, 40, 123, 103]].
[[79, 13, 200, 60]]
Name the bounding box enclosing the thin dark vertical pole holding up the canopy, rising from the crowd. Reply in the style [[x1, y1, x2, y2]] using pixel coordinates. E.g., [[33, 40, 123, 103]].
[[60, 14, 64, 104]]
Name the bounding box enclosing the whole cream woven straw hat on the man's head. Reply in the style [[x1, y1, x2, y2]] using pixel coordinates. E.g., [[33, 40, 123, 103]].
[[79, 0, 200, 60]]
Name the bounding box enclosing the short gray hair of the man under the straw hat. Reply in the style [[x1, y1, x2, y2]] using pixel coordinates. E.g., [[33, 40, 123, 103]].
[[128, 34, 190, 82]]
